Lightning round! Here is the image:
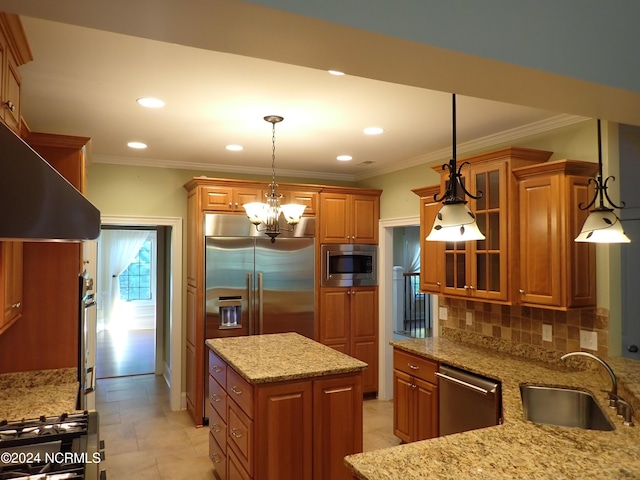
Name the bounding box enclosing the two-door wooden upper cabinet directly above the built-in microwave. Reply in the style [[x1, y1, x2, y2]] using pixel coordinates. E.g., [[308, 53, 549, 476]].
[[319, 187, 382, 245]]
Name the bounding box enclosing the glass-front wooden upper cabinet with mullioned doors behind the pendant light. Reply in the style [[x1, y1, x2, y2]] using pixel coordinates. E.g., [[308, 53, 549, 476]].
[[415, 148, 551, 303]]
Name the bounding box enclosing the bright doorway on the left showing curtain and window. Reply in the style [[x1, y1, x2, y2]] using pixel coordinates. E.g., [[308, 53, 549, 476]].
[[96, 225, 159, 378]]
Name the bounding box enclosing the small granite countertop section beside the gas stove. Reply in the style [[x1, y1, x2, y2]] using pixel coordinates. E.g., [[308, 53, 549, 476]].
[[0, 368, 78, 421]]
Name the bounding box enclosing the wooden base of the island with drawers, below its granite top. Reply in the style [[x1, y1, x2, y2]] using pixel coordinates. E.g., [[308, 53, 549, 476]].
[[208, 351, 362, 480]]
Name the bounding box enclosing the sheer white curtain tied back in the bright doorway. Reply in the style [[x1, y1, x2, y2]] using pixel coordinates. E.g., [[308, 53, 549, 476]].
[[99, 230, 149, 329]]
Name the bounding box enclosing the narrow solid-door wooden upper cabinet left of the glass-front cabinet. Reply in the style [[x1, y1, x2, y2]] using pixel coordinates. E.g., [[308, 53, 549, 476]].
[[413, 185, 444, 294]]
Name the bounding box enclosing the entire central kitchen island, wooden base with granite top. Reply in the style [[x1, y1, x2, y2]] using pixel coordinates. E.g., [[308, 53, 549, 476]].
[[206, 333, 367, 480]]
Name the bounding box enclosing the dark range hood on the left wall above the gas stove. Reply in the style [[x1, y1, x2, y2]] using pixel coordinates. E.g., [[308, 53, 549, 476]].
[[0, 122, 100, 241]]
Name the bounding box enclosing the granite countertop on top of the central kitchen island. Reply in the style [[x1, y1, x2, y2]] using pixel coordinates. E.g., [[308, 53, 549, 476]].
[[206, 333, 367, 384]]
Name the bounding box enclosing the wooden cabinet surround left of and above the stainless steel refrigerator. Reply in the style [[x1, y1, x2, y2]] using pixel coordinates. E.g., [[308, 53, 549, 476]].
[[184, 177, 322, 424]]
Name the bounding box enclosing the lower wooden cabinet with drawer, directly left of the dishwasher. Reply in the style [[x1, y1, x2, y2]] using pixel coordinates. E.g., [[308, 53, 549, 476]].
[[393, 349, 438, 442]]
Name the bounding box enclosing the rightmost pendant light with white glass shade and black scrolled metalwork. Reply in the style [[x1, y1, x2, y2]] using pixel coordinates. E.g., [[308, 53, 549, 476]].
[[575, 119, 631, 243]]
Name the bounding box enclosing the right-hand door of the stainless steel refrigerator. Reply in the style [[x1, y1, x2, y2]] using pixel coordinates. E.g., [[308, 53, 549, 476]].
[[254, 237, 315, 339]]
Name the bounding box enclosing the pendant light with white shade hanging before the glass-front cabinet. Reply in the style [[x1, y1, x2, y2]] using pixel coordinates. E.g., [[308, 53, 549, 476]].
[[426, 93, 485, 242]]
